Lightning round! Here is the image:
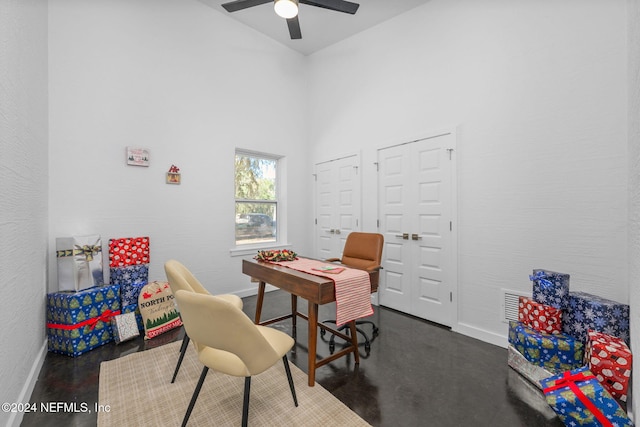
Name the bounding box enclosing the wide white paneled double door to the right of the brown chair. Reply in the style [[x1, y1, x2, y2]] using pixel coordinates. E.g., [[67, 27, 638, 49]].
[[378, 134, 456, 326]]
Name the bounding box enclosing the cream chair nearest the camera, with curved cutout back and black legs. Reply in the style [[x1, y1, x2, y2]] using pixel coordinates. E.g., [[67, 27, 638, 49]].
[[176, 290, 298, 427]]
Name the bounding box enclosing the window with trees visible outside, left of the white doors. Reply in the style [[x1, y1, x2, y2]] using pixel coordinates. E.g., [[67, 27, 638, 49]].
[[235, 151, 278, 245]]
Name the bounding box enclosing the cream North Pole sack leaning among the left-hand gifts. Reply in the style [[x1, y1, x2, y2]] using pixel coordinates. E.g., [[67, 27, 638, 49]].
[[138, 281, 182, 339]]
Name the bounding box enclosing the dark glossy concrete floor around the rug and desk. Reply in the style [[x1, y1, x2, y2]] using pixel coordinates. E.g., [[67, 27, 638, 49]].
[[22, 291, 563, 427]]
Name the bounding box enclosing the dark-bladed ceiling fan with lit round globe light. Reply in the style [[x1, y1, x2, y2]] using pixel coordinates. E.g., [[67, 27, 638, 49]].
[[222, 0, 360, 40]]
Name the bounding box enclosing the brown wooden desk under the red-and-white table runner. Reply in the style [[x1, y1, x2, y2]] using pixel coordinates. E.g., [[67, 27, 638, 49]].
[[242, 259, 379, 387]]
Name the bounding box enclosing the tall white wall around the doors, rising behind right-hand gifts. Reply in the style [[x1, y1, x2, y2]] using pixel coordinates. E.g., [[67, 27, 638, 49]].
[[309, 0, 629, 345]]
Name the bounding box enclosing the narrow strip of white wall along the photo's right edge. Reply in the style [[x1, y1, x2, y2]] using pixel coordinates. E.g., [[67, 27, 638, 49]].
[[627, 0, 640, 424]]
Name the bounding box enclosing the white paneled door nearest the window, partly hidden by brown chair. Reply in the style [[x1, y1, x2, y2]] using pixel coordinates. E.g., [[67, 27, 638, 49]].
[[315, 155, 360, 259]]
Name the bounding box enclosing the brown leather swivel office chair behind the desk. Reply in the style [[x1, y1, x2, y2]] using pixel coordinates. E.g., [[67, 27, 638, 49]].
[[320, 231, 384, 353]]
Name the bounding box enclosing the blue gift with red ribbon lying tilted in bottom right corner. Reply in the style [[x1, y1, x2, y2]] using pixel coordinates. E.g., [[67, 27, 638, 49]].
[[541, 366, 633, 427]]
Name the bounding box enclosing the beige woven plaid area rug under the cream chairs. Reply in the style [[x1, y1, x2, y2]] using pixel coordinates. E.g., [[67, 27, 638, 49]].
[[98, 342, 369, 427]]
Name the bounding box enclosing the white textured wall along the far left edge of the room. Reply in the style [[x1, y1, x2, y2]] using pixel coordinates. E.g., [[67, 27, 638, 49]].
[[0, 0, 48, 425]]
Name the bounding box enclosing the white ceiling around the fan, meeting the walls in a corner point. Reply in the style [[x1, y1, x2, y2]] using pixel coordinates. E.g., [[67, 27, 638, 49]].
[[198, 0, 429, 55]]
